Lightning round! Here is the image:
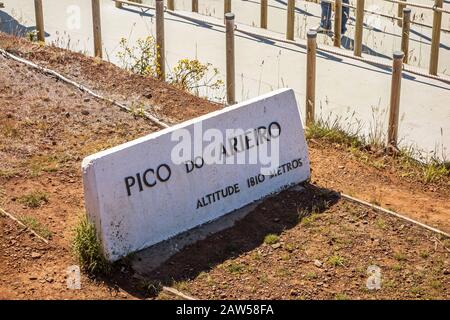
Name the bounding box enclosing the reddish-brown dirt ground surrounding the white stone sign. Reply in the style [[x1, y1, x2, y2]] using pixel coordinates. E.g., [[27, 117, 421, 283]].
[[0, 34, 450, 299]]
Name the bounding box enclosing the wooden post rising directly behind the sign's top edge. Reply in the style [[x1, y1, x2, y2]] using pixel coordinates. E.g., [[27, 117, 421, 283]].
[[225, 12, 236, 105]]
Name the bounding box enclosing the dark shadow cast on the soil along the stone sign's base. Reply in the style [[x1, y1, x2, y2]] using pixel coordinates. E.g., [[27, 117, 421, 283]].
[[106, 184, 339, 298]]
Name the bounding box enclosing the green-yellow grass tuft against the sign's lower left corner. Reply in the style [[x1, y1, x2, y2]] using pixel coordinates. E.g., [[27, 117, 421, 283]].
[[73, 215, 111, 274]]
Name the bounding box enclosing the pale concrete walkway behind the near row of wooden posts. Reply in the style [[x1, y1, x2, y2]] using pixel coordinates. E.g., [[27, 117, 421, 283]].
[[0, 0, 450, 160]]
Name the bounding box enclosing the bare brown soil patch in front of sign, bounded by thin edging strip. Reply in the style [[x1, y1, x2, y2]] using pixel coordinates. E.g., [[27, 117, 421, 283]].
[[154, 185, 450, 299]]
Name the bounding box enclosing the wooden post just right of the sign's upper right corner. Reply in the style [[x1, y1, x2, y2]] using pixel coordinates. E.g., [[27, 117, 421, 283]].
[[305, 30, 317, 126]]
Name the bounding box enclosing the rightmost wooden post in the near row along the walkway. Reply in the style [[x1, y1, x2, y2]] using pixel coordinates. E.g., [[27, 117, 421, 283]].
[[387, 51, 403, 147]]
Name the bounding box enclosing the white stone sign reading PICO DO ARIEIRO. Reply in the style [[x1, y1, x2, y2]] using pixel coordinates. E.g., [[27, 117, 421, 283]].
[[82, 89, 310, 261]]
